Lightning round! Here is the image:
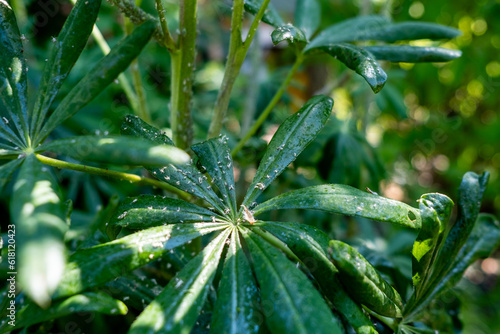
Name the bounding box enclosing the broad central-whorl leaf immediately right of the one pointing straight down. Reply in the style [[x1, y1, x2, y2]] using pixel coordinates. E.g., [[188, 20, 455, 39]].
[[242, 229, 341, 333]]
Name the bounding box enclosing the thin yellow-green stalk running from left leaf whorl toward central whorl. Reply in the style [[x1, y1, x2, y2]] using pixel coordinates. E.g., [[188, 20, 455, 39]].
[[36, 154, 190, 199]]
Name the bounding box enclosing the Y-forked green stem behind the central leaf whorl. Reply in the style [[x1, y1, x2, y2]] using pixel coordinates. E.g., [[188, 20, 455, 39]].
[[208, 0, 270, 138]]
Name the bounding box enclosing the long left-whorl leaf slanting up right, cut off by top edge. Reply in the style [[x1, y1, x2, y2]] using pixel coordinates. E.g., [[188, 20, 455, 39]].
[[31, 0, 101, 137]]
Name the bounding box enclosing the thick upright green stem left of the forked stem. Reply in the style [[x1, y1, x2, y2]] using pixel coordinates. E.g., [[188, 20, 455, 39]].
[[170, 0, 196, 149]]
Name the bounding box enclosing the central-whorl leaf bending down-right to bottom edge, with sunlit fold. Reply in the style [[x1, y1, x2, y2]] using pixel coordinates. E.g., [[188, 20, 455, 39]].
[[254, 221, 377, 334]]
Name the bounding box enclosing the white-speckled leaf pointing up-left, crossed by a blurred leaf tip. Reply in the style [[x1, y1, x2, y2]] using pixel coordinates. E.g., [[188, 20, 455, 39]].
[[121, 116, 228, 214]]
